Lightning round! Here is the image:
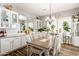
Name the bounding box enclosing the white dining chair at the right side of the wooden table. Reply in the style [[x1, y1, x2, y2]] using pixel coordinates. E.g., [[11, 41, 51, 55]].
[[49, 35, 61, 56]]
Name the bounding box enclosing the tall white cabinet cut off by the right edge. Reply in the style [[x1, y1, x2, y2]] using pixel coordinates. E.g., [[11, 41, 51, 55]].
[[72, 22, 79, 47]]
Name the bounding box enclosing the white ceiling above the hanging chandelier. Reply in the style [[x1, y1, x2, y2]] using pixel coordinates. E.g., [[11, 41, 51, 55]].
[[1, 3, 79, 16]]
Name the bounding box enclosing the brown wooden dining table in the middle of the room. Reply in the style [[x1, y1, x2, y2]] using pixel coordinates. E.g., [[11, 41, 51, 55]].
[[27, 34, 57, 56]]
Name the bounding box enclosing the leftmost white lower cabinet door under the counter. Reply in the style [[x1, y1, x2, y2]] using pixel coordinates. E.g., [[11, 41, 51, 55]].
[[1, 38, 12, 53]]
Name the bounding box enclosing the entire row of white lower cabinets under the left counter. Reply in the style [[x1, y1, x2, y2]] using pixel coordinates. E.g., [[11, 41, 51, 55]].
[[0, 35, 31, 54]]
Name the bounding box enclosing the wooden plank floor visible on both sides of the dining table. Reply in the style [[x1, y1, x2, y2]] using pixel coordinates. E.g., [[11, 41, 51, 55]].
[[5, 44, 79, 56]]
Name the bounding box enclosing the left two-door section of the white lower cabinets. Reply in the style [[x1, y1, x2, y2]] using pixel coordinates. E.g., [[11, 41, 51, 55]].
[[1, 37, 21, 54]]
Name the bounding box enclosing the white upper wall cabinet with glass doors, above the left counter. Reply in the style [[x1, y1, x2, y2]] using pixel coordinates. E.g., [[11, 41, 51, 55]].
[[0, 8, 18, 28]]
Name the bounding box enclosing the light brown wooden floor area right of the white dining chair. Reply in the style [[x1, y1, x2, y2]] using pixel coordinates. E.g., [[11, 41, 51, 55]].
[[60, 44, 79, 56]]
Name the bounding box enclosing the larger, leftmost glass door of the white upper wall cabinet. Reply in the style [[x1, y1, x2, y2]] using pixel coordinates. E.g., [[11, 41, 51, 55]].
[[0, 8, 10, 28]]
